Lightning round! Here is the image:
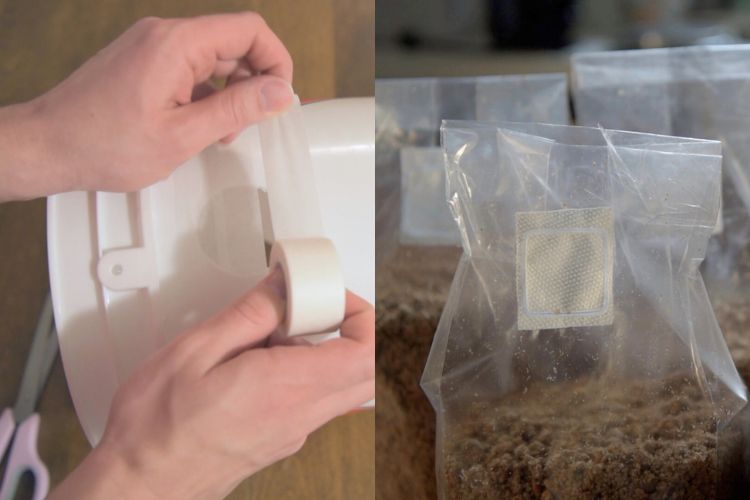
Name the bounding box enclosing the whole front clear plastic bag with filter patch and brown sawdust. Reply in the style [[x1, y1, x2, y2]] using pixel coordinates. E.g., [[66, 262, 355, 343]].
[[422, 121, 746, 499]]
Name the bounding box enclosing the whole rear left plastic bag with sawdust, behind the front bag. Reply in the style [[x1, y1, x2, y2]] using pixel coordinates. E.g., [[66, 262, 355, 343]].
[[375, 74, 568, 498]]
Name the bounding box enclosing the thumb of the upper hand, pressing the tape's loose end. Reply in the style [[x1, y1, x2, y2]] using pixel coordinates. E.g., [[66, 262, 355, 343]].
[[176, 75, 294, 149]]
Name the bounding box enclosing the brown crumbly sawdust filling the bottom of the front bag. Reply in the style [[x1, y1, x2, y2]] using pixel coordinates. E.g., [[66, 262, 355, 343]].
[[444, 374, 748, 499]]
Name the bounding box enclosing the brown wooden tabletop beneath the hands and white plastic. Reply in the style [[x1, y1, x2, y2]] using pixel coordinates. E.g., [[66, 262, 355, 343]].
[[0, 0, 375, 500]]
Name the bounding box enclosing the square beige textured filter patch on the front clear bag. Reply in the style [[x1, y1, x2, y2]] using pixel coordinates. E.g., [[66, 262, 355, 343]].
[[516, 207, 615, 330]]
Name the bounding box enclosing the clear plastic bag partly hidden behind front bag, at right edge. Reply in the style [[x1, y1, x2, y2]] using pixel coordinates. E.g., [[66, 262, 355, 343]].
[[572, 45, 750, 302]]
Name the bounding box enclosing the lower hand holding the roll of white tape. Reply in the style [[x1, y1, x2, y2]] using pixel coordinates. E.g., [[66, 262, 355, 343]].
[[50, 272, 375, 500]]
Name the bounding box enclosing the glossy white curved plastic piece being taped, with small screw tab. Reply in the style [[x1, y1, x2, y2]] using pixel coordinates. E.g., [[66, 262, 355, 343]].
[[47, 98, 375, 444]]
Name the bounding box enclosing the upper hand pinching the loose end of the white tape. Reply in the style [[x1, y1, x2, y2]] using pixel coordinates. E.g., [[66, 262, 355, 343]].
[[0, 12, 293, 200]]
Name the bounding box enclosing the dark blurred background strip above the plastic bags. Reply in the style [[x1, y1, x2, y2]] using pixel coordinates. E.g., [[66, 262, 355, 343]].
[[375, 0, 750, 77]]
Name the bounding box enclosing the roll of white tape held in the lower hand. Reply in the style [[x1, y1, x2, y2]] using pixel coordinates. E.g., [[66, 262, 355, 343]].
[[269, 238, 346, 336]]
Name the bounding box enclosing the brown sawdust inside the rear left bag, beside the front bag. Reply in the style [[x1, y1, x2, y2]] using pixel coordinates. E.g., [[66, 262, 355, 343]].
[[376, 247, 461, 500]]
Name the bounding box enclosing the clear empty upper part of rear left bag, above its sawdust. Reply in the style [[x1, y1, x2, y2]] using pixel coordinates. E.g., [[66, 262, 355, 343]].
[[375, 74, 569, 258]]
